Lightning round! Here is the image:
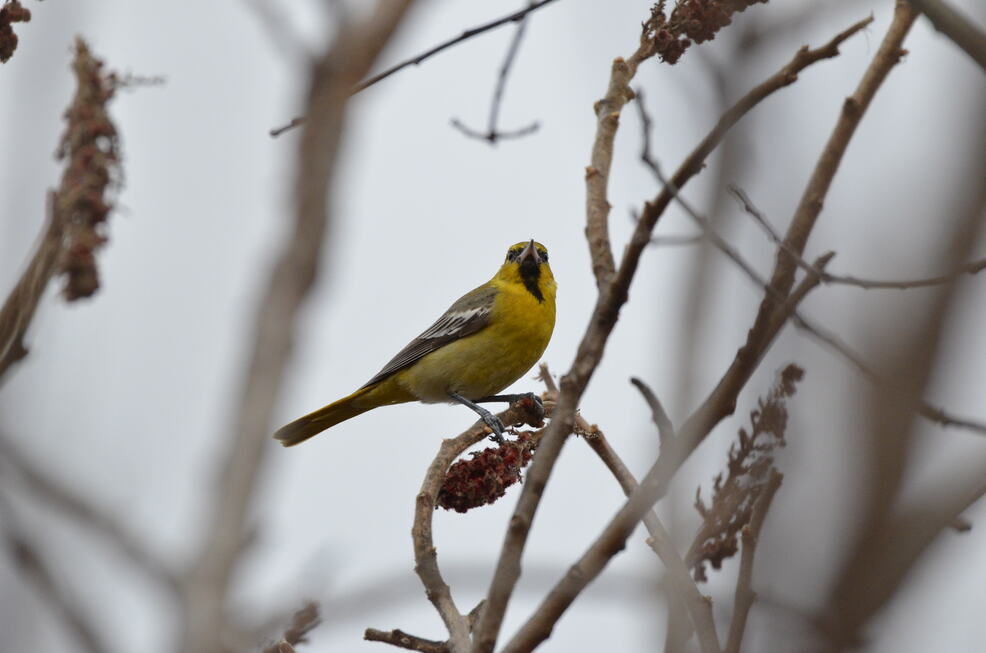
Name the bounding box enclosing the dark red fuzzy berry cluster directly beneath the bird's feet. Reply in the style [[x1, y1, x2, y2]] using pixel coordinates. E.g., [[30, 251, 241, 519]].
[[437, 432, 537, 512]]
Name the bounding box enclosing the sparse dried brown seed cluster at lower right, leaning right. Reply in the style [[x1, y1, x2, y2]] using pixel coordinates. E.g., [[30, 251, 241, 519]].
[[686, 364, 804, 581]]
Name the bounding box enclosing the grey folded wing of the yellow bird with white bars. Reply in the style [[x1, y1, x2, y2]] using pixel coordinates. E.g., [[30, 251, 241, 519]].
[[363, 286, 497, 388]]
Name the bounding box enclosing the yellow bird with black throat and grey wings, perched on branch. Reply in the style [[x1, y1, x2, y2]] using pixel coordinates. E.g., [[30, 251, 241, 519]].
[[274, 239, 555, 447]]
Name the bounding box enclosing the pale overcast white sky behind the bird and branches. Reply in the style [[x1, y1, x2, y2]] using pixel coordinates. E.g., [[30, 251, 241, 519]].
[[0, 0, 986, 653]]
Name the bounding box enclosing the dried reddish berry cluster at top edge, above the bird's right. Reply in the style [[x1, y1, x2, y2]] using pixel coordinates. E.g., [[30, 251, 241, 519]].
[[643, 0, 767, 64]]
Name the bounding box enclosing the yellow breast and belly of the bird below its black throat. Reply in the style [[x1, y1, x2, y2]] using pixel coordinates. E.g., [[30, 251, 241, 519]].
[[394, 266, 555, 402]]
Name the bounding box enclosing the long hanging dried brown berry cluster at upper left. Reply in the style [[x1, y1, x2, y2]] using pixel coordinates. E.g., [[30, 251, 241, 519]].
[[55, 39, 120, 301]]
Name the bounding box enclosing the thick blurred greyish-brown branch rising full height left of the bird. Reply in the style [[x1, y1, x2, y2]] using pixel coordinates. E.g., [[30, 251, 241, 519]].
[[178, 0, 413, 653]]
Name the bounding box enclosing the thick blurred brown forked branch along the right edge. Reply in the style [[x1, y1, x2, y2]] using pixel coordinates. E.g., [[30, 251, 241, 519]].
[[819, 79, 986, 651]]
